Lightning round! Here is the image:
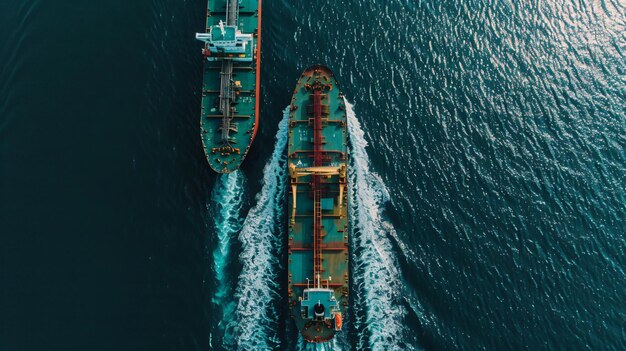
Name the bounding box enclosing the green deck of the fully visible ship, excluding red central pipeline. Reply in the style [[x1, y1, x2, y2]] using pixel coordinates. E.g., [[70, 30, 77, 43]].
[[287, 66, 348, 342]]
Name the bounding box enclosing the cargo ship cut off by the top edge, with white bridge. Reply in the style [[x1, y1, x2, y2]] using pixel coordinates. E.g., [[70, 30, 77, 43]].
[[196, 0, 261, 173]]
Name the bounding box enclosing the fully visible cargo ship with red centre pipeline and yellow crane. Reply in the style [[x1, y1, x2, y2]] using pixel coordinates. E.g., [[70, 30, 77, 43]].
[[287, 65, 349, 342]]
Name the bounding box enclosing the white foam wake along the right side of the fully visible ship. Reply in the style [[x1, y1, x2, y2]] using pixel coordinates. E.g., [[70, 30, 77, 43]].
[[346, 101, 410, 351]]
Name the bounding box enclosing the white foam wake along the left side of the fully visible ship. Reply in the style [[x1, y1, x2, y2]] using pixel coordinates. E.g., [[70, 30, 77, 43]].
[[229, 108, 289, 350]]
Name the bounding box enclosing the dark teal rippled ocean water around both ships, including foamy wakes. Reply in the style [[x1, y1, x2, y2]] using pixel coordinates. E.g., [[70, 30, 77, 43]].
[[0, 0, 626, 351]]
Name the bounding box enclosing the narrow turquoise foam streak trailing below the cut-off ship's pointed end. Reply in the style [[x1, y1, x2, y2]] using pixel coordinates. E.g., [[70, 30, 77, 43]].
[[211, 171, 244, 340]]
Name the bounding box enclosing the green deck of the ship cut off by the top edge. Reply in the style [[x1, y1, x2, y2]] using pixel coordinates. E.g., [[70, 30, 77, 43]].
[[201, 0, 261, 173]]
